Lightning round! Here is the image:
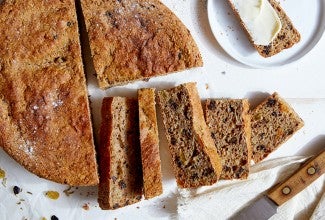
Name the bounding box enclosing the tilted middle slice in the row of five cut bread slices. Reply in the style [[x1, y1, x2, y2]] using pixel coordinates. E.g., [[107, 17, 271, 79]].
[[158, 83, 222, 188]]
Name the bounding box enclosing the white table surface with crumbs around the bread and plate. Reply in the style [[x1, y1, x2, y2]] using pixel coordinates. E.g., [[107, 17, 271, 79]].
[[0, 0, 325, 220]]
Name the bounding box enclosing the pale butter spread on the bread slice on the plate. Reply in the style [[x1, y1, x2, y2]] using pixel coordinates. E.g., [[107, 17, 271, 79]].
[[232, 0, 282, 46]]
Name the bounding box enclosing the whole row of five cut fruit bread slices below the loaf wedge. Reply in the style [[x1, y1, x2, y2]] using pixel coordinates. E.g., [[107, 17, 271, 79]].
[[99, 83, 304, 209]]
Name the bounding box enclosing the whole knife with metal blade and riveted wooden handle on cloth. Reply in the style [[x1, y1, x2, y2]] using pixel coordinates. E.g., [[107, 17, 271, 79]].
[[231, 149, 325, 220]]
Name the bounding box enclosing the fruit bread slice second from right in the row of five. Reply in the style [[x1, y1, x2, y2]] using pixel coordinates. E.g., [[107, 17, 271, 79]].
[[205, 99, 252, 179]]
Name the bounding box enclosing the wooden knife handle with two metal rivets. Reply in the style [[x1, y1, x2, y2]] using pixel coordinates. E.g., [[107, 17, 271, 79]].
[[267, 150, 325, 206]]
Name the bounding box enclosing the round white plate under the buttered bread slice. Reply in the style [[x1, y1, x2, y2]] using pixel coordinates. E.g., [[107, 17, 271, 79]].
[[208, 0, 325, 68]]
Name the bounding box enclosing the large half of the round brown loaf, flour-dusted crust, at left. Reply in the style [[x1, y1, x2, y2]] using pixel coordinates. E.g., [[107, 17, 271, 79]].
[[0, 0, 98, 186]]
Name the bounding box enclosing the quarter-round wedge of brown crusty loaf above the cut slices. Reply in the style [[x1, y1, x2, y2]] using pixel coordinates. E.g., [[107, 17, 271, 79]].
[[81, 0, 203, 89]]
